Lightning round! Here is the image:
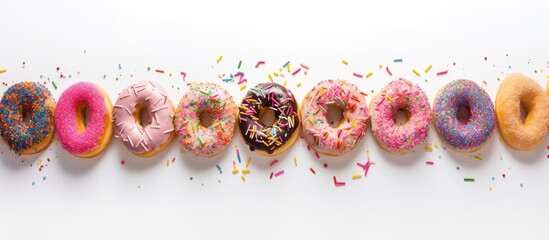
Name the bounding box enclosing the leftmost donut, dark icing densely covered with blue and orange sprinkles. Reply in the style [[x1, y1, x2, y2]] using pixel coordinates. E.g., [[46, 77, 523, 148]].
[[0, 82, 55, 155]]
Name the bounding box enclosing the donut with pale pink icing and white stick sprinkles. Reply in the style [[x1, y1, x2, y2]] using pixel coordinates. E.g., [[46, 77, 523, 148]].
[[113, 81, 175, 157]]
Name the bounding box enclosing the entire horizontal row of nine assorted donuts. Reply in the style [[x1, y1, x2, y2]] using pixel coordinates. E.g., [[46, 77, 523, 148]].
[[0, 73, 549, 158]]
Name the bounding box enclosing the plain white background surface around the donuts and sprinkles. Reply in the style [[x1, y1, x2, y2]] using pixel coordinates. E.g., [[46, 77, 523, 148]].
[[0, 0, 549, 239]]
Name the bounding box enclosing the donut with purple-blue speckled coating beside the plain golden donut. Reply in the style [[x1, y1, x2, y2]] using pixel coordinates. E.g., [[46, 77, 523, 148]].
[[433, 79, 496, 152]]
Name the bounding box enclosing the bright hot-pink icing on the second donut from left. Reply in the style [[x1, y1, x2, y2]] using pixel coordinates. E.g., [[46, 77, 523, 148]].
[[55, 82, 108, 154]]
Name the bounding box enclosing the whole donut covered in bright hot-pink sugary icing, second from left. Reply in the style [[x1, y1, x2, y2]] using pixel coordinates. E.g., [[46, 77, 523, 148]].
[[55, 82, 113, 158]]
